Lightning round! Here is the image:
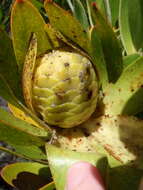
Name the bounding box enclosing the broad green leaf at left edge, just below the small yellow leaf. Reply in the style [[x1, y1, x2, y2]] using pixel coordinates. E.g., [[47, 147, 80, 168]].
[[0, 108, 49, 159]]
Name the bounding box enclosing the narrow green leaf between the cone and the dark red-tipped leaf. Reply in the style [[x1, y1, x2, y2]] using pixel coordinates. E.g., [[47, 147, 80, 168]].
[[91, 28, 108, 89]]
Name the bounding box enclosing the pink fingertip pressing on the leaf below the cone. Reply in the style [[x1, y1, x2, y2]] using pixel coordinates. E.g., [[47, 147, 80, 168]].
[[66, 162, 105, 190]]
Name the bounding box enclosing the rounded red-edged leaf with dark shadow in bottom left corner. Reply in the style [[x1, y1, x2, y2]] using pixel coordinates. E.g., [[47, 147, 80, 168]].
[[1, 162, 51, 190]]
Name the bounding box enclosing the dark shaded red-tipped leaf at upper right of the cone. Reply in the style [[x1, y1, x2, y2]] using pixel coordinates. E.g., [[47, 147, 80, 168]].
[[91, 2, 123, 83]]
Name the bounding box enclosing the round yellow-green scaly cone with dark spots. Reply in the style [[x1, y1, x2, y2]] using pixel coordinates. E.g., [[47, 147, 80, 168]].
[[32, 51, 98, 128]]
